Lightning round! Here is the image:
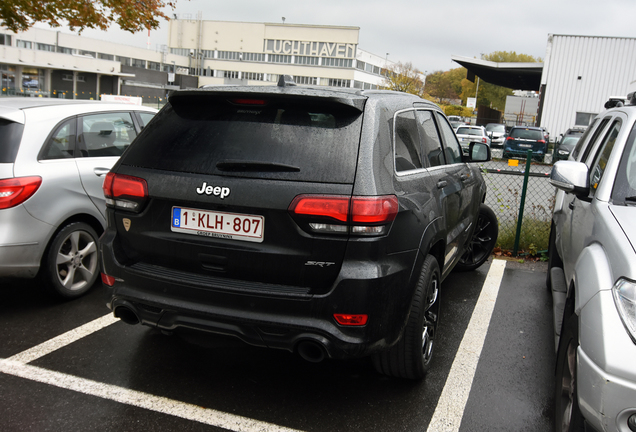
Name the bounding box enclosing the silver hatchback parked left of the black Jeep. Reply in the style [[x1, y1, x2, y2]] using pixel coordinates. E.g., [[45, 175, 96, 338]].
[[0, 97, 157, 298]]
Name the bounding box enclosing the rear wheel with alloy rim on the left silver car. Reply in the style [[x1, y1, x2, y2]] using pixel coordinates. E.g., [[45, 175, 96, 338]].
[[42, 222, 99, 299]]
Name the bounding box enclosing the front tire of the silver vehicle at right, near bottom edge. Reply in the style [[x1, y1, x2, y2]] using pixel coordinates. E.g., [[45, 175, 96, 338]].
[[554, 308, 585, 432]]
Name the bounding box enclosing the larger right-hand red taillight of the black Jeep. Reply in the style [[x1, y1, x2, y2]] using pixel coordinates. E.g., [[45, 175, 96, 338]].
[[289, 195, 398, 235]]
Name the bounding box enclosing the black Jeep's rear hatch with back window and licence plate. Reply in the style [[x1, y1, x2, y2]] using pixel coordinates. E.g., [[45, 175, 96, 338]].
[[107, 89, 364, 293]]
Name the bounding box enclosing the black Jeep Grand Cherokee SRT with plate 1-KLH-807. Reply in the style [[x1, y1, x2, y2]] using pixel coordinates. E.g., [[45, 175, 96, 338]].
[[100, 77, 497, 379]]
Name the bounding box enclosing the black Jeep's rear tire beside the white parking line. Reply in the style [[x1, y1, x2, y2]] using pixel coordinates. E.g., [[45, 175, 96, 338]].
[[373, 255, 441, 380]]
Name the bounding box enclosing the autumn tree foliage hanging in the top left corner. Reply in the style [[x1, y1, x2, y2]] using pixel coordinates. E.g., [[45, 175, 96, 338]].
[[0, 0, 175, 33]]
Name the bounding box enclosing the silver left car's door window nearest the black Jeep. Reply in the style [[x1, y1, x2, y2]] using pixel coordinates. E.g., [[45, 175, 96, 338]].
[[80, 112, 137, 157]]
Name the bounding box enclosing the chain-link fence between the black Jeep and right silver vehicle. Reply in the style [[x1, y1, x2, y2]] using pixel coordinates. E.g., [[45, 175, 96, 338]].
[[480, 150, 555, 255]]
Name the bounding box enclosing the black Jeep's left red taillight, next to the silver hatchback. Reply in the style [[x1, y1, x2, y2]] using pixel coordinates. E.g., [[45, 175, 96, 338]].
[[103, 172, 148, 212]]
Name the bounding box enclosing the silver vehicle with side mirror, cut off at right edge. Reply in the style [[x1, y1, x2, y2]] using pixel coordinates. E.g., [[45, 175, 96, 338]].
[[547, 94, 636, 432]]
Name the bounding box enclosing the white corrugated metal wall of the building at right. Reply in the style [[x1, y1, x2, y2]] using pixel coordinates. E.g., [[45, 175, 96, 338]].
[[541, 35, 636, 138]]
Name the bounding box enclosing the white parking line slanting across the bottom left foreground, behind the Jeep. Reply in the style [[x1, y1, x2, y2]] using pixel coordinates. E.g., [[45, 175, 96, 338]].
[[0, 359, 297, 432]]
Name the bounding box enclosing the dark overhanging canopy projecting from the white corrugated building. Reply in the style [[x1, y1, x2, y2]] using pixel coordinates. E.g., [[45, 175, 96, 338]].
[[451, 56, 543, 91]]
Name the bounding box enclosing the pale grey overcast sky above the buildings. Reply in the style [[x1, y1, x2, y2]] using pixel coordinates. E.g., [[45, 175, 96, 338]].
[[52, 0, 636, 73]]
